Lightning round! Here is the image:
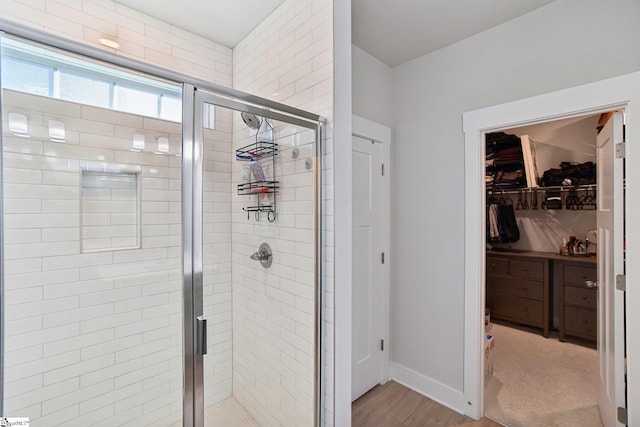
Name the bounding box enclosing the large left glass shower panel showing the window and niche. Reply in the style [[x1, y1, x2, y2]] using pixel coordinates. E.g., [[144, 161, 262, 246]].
[[1, 38, 188, 427]]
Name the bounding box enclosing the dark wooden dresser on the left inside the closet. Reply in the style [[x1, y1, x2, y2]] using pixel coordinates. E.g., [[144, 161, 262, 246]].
[[486, 251, 550, 338]]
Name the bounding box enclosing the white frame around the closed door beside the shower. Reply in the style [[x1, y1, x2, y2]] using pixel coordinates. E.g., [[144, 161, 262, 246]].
[[352, 115, 393, 384]]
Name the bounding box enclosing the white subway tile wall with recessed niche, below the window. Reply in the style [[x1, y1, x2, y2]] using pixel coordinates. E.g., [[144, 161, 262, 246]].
[[3, 90, 216, 427]]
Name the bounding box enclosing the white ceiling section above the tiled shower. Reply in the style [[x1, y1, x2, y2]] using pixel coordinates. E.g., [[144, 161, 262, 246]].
[[115, 0, 284, 47]]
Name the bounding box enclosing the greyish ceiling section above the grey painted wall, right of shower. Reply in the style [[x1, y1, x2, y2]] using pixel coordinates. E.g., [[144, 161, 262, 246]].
[[352, 0, 553, 68]]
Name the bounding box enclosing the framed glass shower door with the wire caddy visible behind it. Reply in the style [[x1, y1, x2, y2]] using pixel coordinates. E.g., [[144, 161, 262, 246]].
[[194, 91, 319, 427]]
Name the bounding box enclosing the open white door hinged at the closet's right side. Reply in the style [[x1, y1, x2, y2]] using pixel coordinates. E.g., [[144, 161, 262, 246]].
[[597, 113, 625, 427]]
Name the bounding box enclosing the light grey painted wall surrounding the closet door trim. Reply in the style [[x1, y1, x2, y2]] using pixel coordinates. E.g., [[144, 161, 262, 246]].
[[391, 0, 640, 411]]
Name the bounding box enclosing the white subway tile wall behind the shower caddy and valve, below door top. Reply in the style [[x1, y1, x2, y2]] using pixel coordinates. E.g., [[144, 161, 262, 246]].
[[232, 113, 317, 426]]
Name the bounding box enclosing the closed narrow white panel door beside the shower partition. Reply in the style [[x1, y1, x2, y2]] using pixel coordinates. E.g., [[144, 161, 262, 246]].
[[351, 136, 384, 400]]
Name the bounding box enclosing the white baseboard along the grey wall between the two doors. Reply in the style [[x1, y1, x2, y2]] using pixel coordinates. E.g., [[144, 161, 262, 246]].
[[389, 363, 465, 414]]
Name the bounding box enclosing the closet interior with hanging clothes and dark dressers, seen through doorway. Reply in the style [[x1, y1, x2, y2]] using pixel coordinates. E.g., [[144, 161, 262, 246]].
[[484, 112, 622, 427]]
